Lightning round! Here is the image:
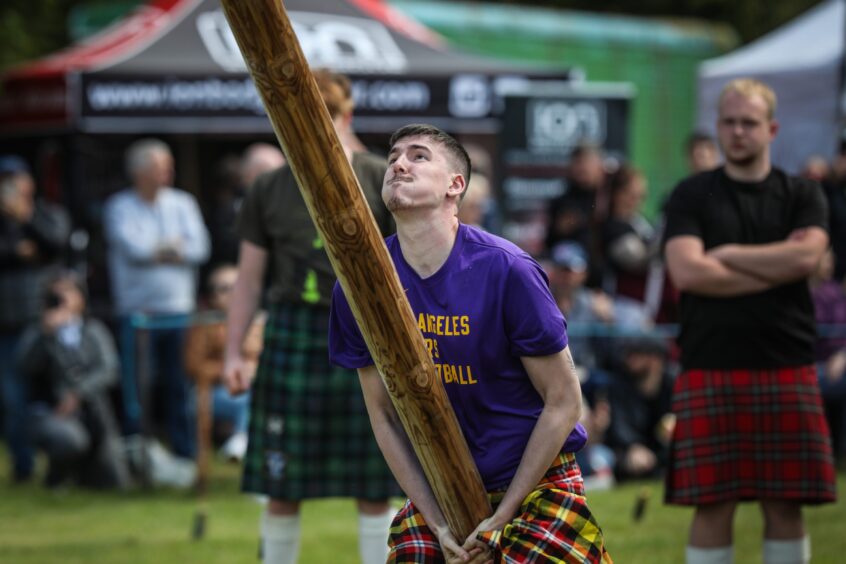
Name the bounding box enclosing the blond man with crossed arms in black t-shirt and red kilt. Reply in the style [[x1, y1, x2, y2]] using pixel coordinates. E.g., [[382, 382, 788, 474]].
[[665, 79, 835, 564]]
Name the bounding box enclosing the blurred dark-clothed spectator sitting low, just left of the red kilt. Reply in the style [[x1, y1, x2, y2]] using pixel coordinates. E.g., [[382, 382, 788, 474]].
[[605, 337, 673, 480]]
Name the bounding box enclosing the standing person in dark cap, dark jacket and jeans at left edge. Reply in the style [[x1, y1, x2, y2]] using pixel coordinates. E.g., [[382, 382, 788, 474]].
[[0, 155, 70, 481]]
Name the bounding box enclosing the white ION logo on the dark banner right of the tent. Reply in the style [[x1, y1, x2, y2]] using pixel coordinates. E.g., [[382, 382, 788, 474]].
[[526, 100, 606, 153]]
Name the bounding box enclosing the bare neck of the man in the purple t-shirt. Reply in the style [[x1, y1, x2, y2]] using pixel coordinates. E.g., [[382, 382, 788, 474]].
[[396, 215, 458, 278]]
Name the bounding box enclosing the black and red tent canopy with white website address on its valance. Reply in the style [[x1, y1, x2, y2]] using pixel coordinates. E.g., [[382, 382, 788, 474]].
[[0, 0, 569, 134]]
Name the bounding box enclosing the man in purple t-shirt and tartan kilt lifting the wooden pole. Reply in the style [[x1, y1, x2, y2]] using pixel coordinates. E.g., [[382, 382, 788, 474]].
[[329, 125, 611, 562]]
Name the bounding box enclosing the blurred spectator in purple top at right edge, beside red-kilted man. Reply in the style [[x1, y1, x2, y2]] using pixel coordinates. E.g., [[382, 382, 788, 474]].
[[810, 250, 846, 459]]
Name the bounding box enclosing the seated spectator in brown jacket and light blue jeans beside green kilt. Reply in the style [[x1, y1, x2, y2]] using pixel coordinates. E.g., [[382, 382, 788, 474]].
[[185, 264, 264, 460]]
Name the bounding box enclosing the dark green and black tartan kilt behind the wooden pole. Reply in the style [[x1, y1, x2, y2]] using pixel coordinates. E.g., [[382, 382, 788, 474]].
[[241, 304, 402, 500]]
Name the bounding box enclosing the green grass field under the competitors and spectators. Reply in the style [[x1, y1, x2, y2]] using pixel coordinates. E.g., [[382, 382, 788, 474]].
[[0, 456, 846, 564]]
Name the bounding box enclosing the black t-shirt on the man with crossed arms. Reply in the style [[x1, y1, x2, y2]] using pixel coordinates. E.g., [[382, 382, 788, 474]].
[[665, 168, 828, 369]]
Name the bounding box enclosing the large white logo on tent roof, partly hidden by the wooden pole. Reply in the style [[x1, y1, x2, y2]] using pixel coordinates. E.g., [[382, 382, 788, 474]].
[[197, 10, 408, 74]]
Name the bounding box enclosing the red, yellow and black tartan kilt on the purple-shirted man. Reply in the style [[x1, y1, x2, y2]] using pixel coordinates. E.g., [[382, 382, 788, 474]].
[[388, 453, 612, 564]]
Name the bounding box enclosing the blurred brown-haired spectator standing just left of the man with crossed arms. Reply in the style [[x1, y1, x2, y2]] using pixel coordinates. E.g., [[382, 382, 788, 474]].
[[602, 166, 658, 302]]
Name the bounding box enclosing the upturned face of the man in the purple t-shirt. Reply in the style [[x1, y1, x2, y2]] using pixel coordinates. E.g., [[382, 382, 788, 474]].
[[382, 135, 463, 212]]
